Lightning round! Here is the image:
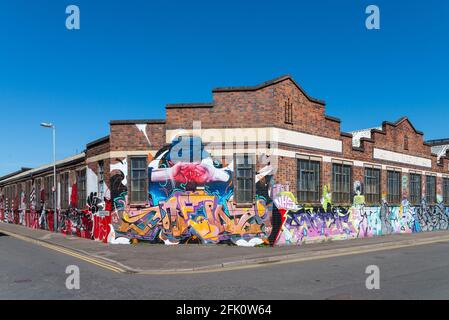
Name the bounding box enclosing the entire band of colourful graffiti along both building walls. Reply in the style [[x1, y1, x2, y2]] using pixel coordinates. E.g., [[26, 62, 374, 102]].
[[0, 132, 449, 246]]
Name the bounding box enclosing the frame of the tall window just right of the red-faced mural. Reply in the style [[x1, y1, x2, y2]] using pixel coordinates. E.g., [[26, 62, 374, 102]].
[[233, 153, 256, 207]]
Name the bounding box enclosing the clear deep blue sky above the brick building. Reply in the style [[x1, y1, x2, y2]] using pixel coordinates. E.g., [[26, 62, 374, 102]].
[[0, 0, 449, 175]]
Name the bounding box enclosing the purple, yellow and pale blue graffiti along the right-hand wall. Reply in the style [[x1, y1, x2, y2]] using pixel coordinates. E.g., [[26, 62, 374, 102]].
[[274, 182, 449, 245]]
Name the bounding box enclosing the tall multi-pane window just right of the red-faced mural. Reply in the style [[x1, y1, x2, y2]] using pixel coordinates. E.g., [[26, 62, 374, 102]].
[[234, 154, 256, 204]]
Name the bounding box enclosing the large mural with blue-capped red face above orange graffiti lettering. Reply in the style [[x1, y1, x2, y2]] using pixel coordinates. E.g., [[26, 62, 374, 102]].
[[111, 136, 272, 246]]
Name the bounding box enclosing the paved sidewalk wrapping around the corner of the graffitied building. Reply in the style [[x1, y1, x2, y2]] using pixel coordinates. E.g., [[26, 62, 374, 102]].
[[0, 223, 449, 274]]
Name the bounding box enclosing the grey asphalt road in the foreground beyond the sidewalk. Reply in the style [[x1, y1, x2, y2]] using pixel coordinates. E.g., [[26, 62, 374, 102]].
[[0, 230, 449, 300]]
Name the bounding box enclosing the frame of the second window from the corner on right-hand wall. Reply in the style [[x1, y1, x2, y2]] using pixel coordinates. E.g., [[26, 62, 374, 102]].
[[332, 162, 353, 204]]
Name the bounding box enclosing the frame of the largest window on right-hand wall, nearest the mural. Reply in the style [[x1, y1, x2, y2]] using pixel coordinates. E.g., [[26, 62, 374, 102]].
[[296, 156, 322, 204]]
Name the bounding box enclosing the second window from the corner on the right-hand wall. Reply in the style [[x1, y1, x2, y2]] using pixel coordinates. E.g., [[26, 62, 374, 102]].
[[332, 163, 352, 203]]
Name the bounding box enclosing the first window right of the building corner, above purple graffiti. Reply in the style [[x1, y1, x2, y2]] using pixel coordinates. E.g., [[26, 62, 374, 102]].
[[297, 159, 321, 203]]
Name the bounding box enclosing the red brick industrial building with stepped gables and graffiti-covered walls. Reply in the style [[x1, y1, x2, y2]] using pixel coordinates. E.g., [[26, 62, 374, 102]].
[[0, 75, 449, 246]]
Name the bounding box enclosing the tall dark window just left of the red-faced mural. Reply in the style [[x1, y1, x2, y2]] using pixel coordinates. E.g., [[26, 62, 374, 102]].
[[130, 157, 148, 204]]
